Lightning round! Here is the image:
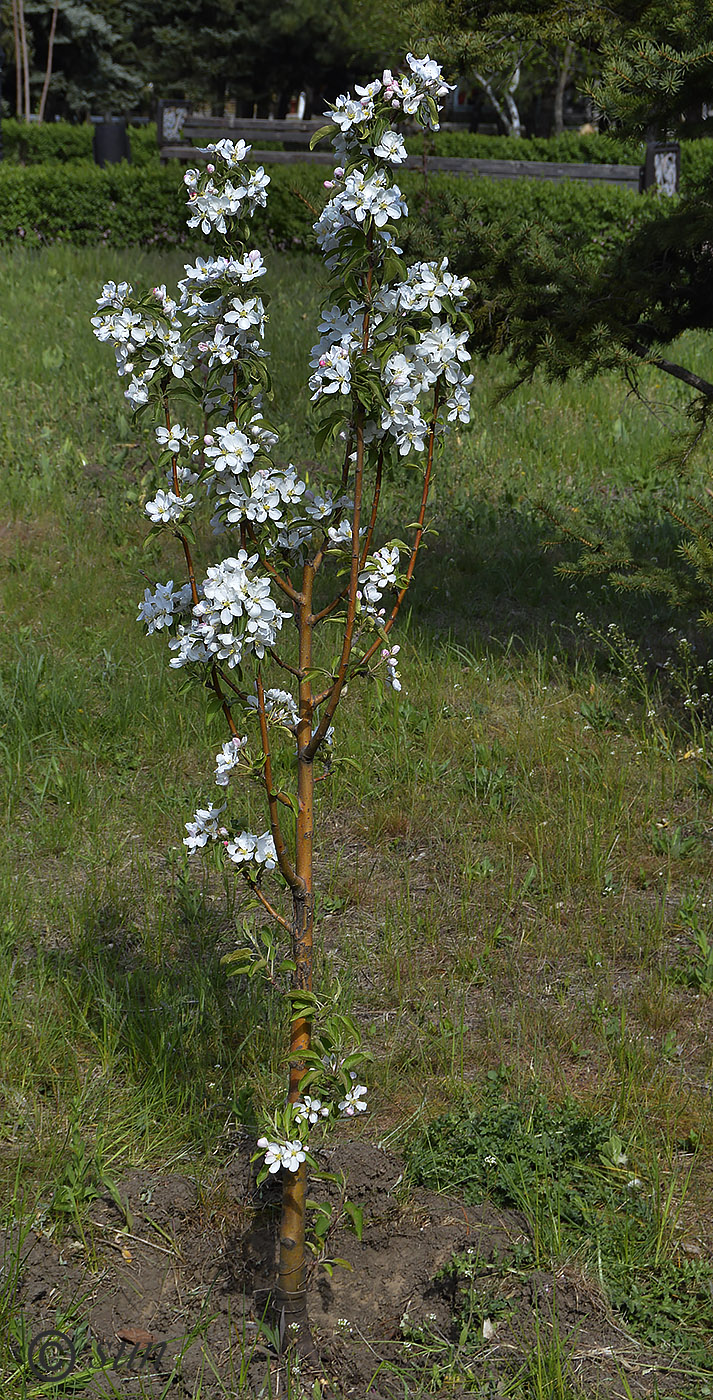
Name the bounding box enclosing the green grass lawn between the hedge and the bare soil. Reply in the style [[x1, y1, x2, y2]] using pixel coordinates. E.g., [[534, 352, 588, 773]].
[[0, 248, 713, 1400]]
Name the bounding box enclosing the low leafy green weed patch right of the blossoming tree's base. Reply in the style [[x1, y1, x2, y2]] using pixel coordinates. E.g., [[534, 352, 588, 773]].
[[408, 1091, 713, 1371]]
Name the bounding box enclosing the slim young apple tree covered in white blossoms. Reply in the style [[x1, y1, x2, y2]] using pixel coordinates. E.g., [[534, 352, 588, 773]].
[[92, 53, 472, 1337]]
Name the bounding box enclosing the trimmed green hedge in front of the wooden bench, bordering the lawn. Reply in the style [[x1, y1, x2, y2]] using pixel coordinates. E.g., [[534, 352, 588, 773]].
[[0, 162, 649, 265]]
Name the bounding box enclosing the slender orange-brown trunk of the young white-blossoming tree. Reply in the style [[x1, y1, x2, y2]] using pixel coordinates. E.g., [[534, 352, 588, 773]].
[[277, 564, 314, 1354]]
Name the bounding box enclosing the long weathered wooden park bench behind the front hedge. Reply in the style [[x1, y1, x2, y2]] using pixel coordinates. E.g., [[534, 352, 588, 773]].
[[157, 101, 672, 190]]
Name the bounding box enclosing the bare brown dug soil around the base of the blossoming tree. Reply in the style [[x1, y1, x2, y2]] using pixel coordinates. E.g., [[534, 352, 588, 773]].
[[6, 1141, 682, 1400]]
